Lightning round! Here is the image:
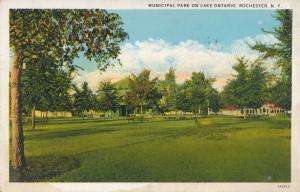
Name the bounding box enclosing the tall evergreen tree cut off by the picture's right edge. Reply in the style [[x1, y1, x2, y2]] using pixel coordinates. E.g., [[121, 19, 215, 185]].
[[250, 10, 293, 109]]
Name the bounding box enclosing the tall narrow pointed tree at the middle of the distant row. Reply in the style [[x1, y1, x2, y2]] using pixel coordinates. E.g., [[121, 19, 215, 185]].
[[160, 68, 177, 111]]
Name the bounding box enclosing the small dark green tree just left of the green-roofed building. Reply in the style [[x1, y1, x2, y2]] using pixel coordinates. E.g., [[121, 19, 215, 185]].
[[97, 81, 120, 117]]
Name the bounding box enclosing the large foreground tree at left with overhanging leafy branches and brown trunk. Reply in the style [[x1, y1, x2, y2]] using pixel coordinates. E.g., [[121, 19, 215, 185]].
[[9, 9, 127, 170]]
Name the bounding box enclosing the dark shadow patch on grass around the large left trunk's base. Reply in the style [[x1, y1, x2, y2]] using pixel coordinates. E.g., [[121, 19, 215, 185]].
[[9, 156, 80, 182]]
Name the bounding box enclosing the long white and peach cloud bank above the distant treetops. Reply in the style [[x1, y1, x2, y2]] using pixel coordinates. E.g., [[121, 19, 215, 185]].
[[75, 34, 277, 90]]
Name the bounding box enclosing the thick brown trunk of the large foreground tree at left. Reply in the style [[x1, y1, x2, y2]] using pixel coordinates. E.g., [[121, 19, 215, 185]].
[[10, 56, 25, 170]]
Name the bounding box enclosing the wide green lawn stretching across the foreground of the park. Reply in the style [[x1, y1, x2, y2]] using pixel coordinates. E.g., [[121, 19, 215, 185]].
[[9, 116, 291, 182]]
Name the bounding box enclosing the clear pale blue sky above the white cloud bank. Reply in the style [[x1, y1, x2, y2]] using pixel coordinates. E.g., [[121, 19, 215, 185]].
[[74, 10, 277, 72]]
